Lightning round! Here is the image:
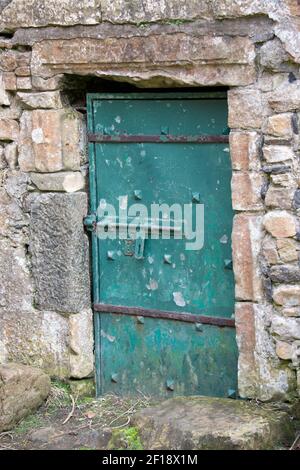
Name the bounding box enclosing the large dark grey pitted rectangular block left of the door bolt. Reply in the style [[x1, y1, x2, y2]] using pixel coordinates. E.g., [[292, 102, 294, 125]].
[[30, 193, 90, 313]]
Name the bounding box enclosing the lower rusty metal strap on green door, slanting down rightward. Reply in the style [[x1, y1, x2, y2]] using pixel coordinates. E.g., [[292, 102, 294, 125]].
[[94, 303, 235, 328]]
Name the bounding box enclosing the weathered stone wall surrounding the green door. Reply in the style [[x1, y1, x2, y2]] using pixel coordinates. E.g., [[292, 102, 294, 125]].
[[0, 0, 300, 400]]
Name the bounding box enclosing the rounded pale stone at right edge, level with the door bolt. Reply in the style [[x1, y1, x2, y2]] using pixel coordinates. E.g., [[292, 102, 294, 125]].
[[264, 211, 297, 238]]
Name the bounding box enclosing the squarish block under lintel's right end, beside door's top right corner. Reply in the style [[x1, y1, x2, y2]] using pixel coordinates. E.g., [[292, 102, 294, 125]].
[[228, 88, 266, 129]]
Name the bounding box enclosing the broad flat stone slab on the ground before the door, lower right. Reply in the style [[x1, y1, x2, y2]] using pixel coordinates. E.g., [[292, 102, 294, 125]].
[[133, 397, 293, 450]]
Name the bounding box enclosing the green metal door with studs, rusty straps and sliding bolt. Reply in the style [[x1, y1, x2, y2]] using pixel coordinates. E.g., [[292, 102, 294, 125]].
[[85, 93, 237, 396]]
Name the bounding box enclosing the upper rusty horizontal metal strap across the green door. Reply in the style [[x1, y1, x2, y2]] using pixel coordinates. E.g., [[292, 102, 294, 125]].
[[88, 133, 229, 144]]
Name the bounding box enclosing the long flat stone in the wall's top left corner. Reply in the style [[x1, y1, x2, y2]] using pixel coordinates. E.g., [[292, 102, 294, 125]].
[[1, 0, 101, 29]]
